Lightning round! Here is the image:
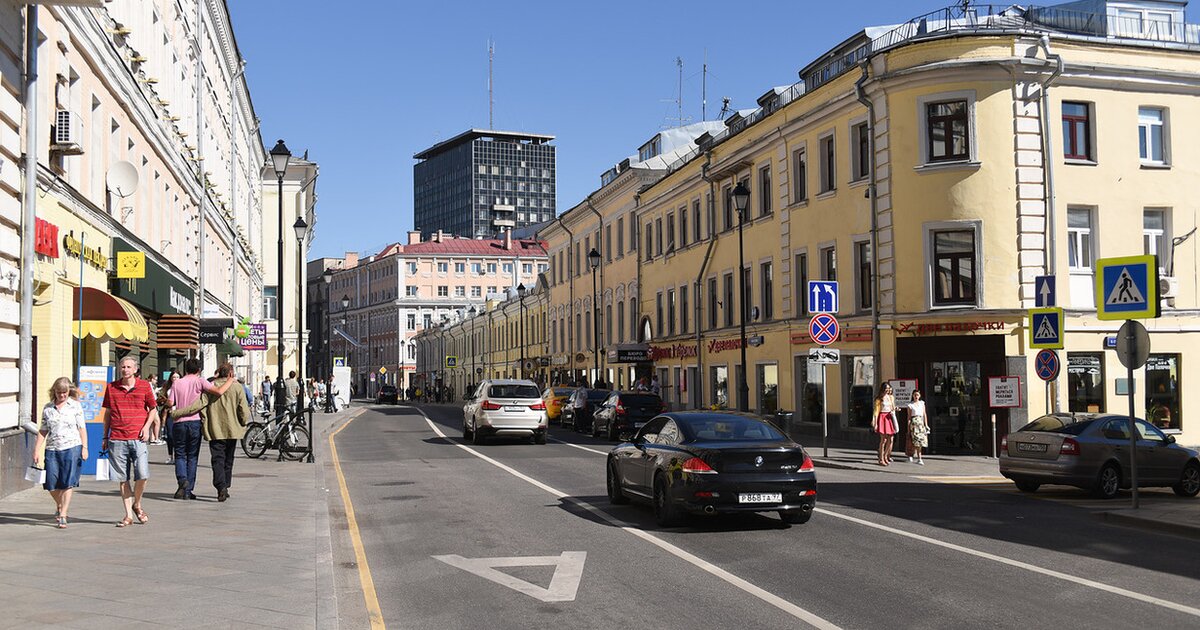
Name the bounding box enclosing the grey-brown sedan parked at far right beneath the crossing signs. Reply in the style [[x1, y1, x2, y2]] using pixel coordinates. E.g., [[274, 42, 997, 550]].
[[1000, 413, 1200, 499]]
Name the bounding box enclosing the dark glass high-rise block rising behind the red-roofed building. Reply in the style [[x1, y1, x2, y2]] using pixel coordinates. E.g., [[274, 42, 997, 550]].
[[413, 130, 557, 239]]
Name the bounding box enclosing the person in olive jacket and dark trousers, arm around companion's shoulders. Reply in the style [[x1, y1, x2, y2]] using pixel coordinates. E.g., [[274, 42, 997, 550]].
[[172, 362, 251, 503]]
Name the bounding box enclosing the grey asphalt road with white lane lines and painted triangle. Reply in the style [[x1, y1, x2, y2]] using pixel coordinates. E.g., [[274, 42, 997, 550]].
[[334, 406, 1200, 629]]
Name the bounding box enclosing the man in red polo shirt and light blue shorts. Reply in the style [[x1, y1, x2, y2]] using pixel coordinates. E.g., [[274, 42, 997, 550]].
[[100, 356, 158, 527]]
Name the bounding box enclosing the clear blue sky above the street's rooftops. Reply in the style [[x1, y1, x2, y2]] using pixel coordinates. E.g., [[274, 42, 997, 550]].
[[228, 0, 1193, 258]]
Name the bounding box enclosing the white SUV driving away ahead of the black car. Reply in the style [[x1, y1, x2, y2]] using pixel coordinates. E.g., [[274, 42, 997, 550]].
[[462, 379, 546, 444]]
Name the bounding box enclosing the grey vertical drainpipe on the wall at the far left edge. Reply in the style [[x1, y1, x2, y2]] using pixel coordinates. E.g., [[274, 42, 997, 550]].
[[17, 4, 38, 433]]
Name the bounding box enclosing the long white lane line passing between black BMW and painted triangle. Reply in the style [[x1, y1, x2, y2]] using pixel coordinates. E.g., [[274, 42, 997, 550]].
[[418, 409, 840, 630]]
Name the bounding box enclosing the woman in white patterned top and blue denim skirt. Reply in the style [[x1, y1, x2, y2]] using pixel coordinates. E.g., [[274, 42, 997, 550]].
[[34, 377, 88, 529]]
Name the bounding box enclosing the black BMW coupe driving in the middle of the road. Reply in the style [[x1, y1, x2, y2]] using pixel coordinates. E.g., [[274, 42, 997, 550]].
[[607, 412, 817, 527]]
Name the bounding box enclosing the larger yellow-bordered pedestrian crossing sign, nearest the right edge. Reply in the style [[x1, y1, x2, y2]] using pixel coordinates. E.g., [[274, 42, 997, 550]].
[[1096, 254, 1159, 319]]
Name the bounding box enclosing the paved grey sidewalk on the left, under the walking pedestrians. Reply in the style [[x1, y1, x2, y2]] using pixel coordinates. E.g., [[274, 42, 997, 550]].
[[0, 407, 355, 630]]
